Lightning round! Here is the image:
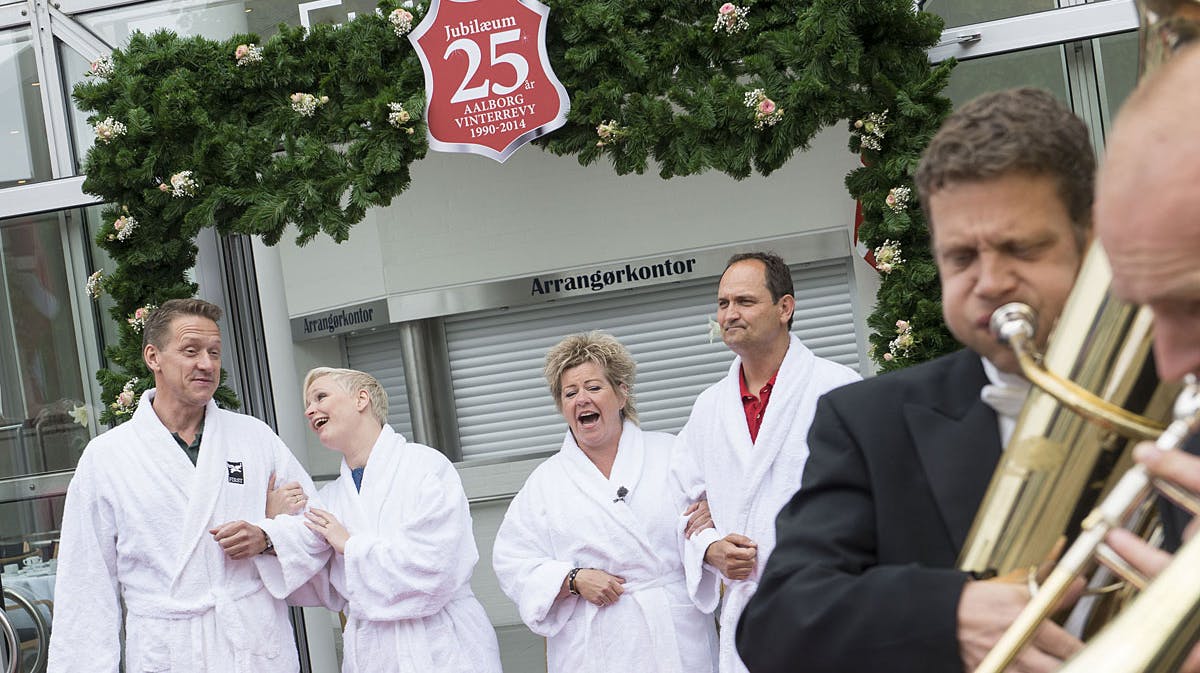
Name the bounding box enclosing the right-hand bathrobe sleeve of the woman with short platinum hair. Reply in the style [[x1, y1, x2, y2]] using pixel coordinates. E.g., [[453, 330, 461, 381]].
[[344, 461, 479, 620]]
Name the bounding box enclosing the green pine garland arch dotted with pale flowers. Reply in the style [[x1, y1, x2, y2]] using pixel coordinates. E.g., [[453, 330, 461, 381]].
[[74, 0, 954, 422]]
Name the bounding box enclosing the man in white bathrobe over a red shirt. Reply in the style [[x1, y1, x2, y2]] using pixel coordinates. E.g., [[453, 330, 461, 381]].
[[673, 252, 859, 673]]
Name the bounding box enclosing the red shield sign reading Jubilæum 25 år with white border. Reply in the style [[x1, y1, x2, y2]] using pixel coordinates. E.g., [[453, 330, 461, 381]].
[[408, 0, 571, 162]]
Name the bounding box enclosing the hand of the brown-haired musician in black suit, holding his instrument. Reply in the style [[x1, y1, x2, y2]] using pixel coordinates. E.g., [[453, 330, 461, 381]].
[[959, 578, 1084, 673]]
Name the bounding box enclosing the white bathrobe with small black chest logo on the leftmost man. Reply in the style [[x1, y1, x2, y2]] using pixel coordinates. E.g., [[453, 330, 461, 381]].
[[49, 390, 329, 673]]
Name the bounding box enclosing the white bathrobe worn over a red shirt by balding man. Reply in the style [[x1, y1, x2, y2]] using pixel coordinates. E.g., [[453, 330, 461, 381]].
[[673, 335, 860, 673]]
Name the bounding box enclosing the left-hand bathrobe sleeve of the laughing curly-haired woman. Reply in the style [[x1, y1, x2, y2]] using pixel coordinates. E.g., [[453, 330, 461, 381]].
[[492, 463, 580, 637]]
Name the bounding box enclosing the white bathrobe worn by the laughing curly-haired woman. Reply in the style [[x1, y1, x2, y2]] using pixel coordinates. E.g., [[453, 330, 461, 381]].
[[492, 421, 718, 673]]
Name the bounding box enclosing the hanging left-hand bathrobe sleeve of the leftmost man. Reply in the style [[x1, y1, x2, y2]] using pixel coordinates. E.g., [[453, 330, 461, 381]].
[[48, 453, 122, 673]]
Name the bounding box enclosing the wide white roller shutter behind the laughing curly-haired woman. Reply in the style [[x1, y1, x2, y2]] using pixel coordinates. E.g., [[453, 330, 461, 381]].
[[445, 260, 858, 458]]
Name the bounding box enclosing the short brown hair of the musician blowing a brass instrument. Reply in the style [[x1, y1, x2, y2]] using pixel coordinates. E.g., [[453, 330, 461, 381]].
[[916, 88, 1096, 250]]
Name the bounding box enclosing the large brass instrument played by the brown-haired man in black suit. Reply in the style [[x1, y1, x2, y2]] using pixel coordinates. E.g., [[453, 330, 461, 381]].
[[959, 245, 1175, 587]]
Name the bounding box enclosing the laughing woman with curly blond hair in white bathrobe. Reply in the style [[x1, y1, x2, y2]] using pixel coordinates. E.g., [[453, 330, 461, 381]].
[[492, 332, 718, 673]]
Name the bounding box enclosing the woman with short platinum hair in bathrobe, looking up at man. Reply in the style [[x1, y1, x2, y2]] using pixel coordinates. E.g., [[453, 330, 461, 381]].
[[278, 367, 500, 673]]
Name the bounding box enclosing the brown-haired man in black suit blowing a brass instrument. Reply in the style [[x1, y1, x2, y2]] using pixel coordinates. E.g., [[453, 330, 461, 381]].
[[737, 89, 1094, 673]]
